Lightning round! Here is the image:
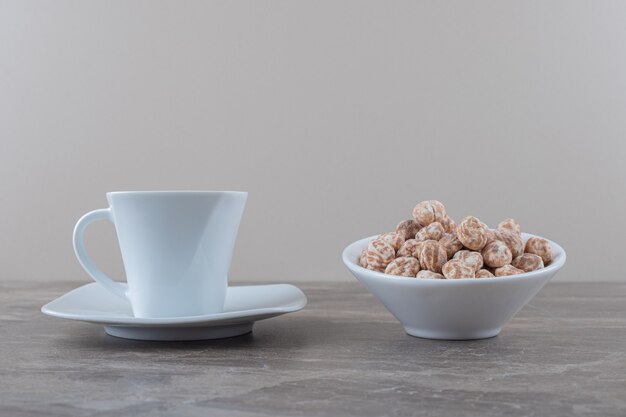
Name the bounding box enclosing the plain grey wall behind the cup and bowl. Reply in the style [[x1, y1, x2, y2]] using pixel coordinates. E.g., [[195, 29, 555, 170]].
[[0, 0, 626, 282]]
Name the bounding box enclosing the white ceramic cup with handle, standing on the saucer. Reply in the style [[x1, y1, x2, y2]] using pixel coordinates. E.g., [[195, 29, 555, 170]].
[[74, 191, 248, 318]]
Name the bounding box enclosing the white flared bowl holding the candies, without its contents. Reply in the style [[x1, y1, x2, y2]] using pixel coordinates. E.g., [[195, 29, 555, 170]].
[[343, 233, 565, 340]]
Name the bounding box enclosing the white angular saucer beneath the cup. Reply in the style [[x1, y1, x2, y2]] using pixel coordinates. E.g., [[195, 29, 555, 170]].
[[41, 282, 307, 340]]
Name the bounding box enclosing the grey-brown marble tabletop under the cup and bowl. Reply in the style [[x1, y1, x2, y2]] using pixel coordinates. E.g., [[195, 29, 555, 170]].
[[0, 282, 626, 417]]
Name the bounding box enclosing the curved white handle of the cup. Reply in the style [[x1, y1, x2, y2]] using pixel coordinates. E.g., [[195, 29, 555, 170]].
[[74, 208, 127, 299]]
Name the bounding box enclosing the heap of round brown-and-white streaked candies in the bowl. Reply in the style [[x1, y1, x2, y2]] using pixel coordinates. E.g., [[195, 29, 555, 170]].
[[366, 200, 553, 279]]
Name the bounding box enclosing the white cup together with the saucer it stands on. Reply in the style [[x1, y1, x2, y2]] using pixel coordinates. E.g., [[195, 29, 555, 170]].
[[41, 191, 307, 341]]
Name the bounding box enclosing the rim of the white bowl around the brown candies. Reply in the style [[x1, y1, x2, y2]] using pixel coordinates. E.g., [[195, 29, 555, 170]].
[[341, 233, 567, 285]]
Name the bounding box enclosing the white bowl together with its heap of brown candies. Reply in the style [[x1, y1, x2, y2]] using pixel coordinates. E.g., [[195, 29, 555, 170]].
[[342, 200, 566, 340]]
